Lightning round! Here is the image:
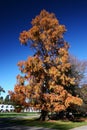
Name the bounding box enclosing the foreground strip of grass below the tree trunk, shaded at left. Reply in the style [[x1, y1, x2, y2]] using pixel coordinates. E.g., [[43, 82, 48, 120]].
[[0, 117, 87, 130]]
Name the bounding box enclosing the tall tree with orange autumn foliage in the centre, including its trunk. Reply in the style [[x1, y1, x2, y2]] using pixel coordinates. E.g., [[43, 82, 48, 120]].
[[9, 10, 82, 120]]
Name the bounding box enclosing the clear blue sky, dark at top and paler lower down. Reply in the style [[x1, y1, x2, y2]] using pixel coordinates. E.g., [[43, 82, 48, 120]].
[[0, 0, 87, 96]]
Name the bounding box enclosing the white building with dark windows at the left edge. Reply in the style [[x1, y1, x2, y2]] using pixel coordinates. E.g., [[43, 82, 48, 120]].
[[0, 104, 15, 112]]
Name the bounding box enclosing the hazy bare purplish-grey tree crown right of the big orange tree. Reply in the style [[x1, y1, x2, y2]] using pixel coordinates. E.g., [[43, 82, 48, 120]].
[[69, 55, 87, 86]]
